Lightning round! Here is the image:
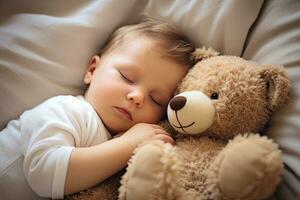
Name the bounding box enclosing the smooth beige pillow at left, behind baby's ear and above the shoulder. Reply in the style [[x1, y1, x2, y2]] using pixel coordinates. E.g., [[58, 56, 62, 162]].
[[0, 0, 146, 129]]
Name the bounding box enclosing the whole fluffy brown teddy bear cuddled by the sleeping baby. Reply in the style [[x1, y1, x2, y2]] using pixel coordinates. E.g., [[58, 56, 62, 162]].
[[119, 48, 290, 200]]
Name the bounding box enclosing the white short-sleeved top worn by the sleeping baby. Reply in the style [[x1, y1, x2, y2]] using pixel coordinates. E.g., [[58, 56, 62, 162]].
[[0, 96, 111, 200]]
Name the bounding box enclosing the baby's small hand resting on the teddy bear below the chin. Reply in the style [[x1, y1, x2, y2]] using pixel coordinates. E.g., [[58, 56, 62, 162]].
[[121, 123, 175, 146]]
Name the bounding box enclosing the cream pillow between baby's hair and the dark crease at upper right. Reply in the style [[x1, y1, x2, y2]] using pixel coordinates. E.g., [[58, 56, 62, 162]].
[[146, 0, 263, 55]]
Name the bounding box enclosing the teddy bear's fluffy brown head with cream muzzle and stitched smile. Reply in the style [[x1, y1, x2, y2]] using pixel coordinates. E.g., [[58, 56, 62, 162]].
[[168, 48, 290, 139]]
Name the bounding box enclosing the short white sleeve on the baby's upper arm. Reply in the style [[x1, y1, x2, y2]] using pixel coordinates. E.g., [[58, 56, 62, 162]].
[[20, 97, 85, 199]]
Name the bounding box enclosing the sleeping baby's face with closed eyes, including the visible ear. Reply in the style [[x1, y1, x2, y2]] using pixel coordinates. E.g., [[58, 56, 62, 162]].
[[84, 37, 187, 134]]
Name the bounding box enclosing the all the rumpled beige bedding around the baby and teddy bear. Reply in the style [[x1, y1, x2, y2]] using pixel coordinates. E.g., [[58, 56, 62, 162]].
[[0, 0, 300, 200]]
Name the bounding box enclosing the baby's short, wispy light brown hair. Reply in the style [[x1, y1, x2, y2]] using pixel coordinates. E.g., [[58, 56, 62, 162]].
[[99, 16, 195, 67]]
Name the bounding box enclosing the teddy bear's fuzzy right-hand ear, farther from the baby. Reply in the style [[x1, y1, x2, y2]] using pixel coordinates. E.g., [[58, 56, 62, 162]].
[[259, 65, 291, 111]]
